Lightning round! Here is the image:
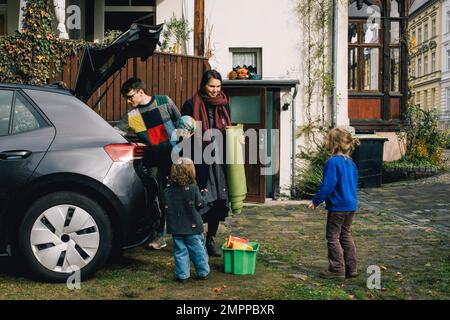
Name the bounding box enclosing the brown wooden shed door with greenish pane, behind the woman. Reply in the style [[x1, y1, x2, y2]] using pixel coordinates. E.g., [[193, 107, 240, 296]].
[[223, 88, 266, 203]]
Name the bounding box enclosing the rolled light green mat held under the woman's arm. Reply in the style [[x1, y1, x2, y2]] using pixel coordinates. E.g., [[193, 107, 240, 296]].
[[225, 124, 247, 213]]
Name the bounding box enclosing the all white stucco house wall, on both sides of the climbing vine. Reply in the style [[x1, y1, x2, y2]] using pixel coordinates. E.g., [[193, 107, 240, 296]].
[[157, 0, 349, 198]]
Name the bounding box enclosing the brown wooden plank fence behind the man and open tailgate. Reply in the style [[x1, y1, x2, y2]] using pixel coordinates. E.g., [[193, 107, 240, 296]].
[[50, 52, 211, 121]]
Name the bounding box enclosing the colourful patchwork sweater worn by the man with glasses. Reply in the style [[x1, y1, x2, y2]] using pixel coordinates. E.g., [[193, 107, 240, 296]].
[[115, 95, 181, 170]]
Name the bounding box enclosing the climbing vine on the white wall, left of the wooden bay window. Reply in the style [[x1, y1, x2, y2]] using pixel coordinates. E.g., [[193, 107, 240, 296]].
[[294, 0, 340, 198]]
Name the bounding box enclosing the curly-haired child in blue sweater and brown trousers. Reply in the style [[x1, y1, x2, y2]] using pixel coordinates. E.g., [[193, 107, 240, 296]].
[[308, 128, 359, 278]]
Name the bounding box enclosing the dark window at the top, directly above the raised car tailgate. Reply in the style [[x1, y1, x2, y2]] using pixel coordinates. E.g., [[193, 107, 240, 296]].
[[104, 0, 156, 31]]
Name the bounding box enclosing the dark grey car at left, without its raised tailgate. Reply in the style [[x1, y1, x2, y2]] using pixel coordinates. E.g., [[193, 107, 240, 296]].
[[0, 84, 157, 281]]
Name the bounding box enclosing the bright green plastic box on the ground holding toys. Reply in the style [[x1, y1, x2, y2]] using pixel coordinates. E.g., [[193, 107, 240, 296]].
[[222, 242, 259, 275]]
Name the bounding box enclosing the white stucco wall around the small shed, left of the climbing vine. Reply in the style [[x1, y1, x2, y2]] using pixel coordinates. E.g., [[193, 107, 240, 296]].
[[205, 0, 303, 193]]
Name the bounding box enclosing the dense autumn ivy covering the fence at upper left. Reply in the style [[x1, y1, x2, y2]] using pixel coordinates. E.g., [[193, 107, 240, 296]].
[[0, 0, 84, 84]]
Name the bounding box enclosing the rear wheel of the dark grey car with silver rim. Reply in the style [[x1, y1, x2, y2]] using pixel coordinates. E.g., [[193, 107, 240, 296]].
[[19, 192, 113, 282]]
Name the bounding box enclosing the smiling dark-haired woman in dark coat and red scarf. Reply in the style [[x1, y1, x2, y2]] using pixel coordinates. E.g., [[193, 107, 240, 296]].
[[181, 70, 231, 257]]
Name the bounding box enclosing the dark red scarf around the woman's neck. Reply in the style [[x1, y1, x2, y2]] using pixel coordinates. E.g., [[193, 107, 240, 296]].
[[192, 91, 231, 132]]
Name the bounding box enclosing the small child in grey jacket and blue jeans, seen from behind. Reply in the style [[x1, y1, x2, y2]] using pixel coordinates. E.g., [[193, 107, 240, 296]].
[[164, 158, 209, 282]]
